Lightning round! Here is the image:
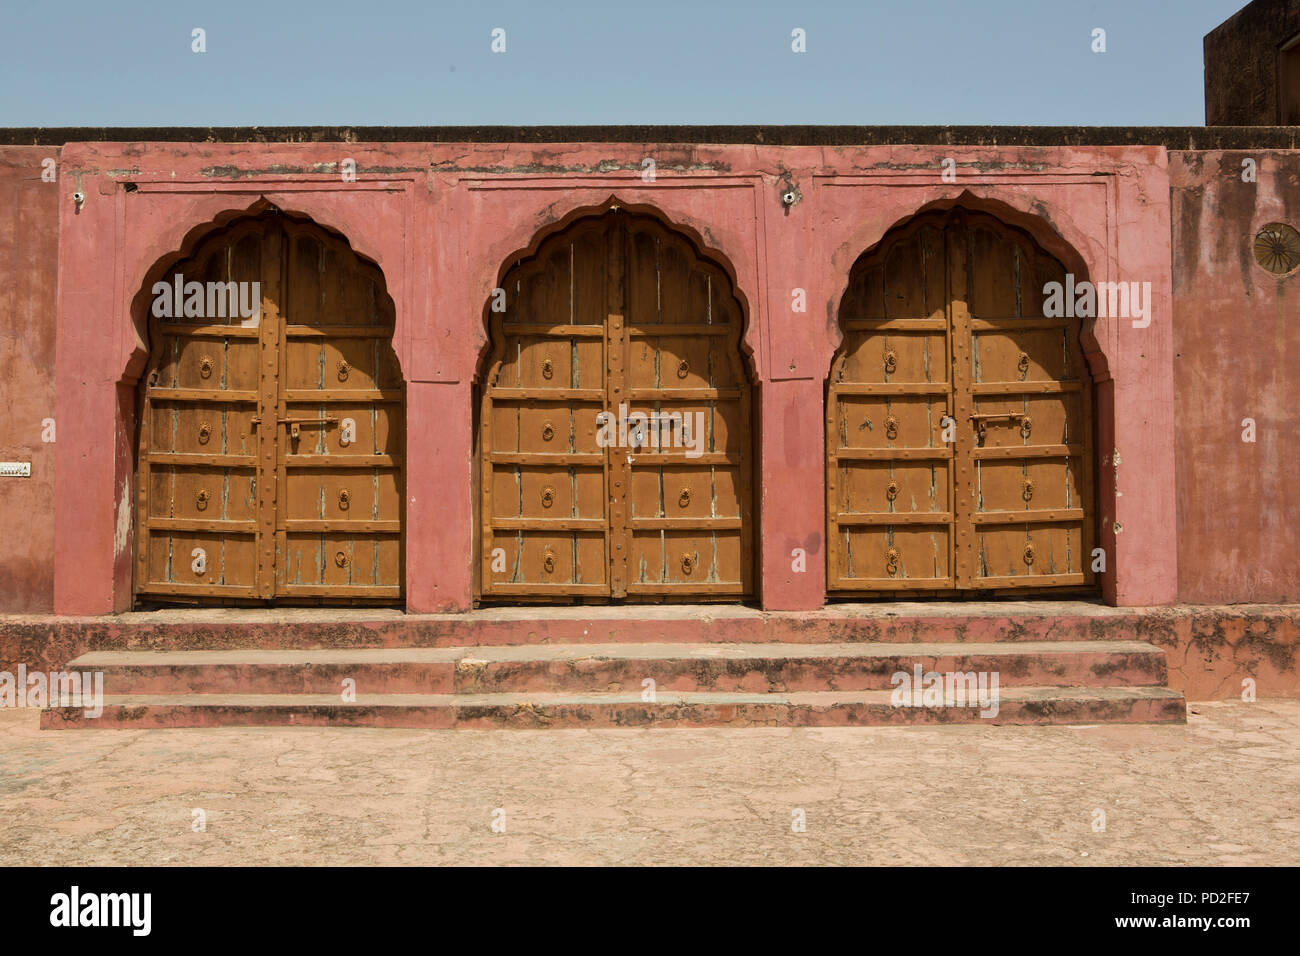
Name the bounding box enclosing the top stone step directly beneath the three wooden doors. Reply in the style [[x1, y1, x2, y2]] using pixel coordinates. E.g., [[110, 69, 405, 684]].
[[0, 601, 1154, 650]]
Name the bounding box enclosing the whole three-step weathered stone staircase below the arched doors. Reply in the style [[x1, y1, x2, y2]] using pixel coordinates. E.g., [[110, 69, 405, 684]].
[[42, 604, 1186, 728]]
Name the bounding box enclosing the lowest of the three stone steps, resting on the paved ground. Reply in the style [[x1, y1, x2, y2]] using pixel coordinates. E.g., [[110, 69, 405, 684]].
[[40, 687, 1187, 730]]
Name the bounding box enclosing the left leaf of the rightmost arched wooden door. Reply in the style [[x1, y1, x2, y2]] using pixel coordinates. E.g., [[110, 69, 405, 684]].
[[827, 226, 953, 591]]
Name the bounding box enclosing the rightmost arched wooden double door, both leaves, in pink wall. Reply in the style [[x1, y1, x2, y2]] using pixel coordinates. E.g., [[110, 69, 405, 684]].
[[826, 207, 1096, 594]]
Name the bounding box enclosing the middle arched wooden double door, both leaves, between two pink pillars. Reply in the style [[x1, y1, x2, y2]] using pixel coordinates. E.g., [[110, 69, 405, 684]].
[[478, 207, 754, 601]]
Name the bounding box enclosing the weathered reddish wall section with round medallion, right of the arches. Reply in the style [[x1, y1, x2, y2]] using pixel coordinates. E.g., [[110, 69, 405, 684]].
[[1170, 151, 1300, 604]]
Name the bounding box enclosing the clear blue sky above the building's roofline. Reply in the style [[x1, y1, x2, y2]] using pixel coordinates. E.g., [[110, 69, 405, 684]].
[[0, 0, 1245, 126]]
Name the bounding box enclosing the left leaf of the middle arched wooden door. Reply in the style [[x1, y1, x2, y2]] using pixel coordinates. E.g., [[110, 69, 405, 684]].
[[480, 223, 608, 600]]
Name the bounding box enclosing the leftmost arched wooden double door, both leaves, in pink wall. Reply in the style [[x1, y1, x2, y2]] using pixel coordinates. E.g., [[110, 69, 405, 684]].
[[135, 209, 406, 604]]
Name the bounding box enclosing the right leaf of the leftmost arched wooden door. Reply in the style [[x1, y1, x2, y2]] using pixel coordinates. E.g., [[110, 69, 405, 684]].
[[276, 222, 404, 600]]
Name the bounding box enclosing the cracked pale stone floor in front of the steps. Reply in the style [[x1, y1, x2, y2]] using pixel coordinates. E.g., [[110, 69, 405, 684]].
[[0, 700, 1300, 866]]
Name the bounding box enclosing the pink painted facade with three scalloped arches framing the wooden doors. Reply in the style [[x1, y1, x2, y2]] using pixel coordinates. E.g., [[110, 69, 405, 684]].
[[27, 143, 1178, 614]]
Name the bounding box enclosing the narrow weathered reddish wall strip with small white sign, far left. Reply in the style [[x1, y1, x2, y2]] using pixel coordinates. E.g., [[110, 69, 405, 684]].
[[0, 146, 59, 611]]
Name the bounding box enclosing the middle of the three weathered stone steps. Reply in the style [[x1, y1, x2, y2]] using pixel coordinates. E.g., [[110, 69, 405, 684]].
[[66, 641, 1167, 695]]
